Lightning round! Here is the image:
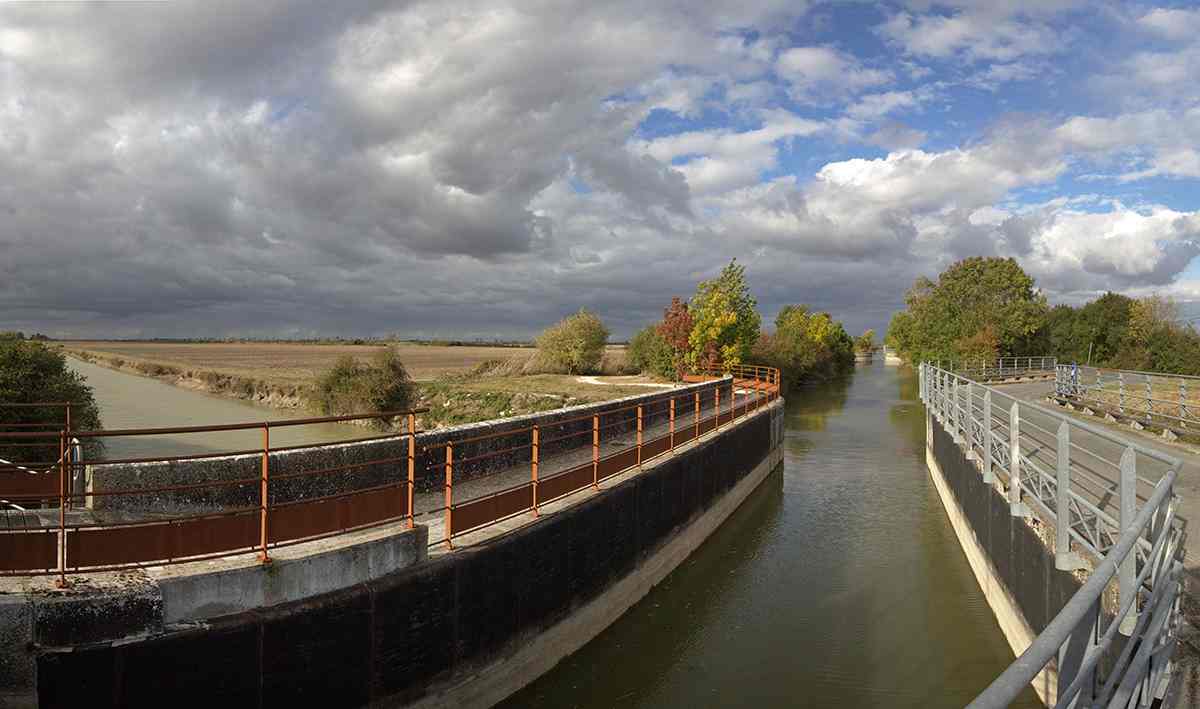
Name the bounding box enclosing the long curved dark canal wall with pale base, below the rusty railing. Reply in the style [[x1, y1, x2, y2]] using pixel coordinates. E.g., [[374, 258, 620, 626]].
[[37, 402, 782, 709]]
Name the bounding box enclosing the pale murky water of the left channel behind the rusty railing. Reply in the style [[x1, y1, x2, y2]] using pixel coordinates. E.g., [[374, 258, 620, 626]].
[[67, 357, 372, 459]]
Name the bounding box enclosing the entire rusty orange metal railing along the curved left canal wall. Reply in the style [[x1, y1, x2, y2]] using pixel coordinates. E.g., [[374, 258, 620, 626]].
[[0, 367, 779, 585]]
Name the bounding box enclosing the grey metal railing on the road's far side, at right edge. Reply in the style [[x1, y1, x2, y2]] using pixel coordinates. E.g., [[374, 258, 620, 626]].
[[1055, 365, 1200, 428]]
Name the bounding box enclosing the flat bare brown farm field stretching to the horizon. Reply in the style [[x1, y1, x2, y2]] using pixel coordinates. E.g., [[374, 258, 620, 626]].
[[60, 341, 534, 386]]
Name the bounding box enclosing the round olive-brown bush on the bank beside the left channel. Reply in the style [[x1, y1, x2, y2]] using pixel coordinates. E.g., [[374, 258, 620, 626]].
[[310, 347, 413, 424]]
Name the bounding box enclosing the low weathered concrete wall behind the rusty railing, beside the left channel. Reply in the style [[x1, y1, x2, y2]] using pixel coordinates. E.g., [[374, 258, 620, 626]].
[[86, 381, 728, 513]]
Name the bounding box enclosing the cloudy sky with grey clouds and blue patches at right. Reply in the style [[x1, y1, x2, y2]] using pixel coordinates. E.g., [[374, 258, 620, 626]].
[[0, 0, 1200, 338]]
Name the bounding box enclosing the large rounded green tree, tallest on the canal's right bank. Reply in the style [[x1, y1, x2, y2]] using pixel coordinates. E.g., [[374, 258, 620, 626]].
[[888, 257, 1048, 362]]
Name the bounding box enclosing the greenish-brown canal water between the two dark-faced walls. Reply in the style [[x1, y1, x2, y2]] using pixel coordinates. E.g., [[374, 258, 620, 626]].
[[505, 362, 1039, 709]]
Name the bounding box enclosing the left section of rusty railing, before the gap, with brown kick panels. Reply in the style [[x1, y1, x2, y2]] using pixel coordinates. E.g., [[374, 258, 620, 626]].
[[0, 409, 427, 585]]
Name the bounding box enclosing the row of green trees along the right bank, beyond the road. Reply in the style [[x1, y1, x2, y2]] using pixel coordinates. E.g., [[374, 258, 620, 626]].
[[884, 257, 1200, 374]]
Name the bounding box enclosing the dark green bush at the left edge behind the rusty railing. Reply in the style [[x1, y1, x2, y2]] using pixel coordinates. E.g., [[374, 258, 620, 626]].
[[0, 340, 102, 462]]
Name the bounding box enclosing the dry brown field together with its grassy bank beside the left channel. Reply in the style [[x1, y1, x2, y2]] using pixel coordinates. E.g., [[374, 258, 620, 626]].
[[61, 342, 650, 428]]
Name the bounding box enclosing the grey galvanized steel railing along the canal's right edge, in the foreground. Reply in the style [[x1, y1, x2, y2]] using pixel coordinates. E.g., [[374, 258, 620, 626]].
[[920, 362, 1184, 709]]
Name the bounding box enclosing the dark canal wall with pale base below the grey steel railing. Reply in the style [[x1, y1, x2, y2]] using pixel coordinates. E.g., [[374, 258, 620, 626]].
[[925, 413, 1082, 704]]
